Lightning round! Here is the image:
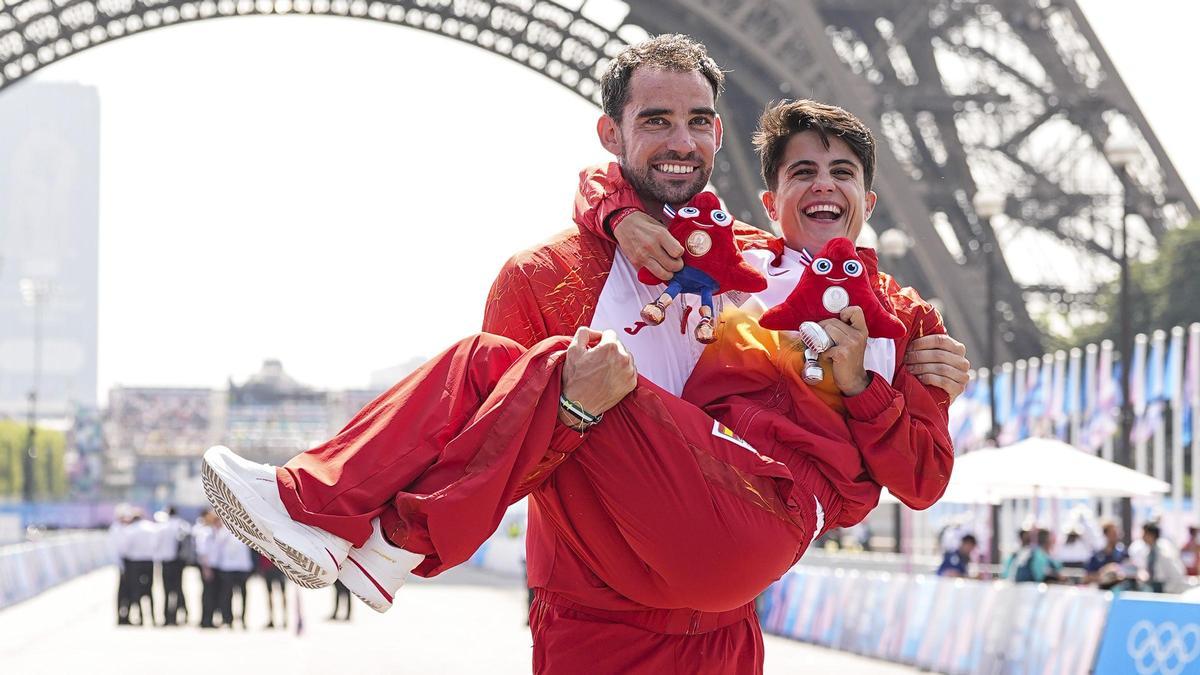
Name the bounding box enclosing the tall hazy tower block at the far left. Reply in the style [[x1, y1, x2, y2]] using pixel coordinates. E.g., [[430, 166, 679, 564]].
[[0, 83, 100, 418]]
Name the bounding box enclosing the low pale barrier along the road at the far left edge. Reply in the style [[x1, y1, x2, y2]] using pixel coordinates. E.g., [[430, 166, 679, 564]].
[[0, 532, 116, 609]]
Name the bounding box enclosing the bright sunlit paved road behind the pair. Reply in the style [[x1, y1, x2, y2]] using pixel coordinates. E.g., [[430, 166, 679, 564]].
[[0, 568, 917, 675]]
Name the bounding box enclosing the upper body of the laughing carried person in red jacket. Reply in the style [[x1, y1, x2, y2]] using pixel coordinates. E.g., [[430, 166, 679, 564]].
[[576, 94, 967, 521]]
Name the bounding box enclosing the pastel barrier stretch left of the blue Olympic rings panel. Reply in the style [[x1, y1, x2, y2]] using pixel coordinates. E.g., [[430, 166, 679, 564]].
[[760, 567, 1110, 674]]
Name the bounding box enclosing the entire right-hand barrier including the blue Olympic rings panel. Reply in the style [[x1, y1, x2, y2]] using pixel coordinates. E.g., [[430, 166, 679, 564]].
[[758, 566, 1200, 675]]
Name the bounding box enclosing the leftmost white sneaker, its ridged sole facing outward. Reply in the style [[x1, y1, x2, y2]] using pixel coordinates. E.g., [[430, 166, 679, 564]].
[[202, 446, 350, 589]]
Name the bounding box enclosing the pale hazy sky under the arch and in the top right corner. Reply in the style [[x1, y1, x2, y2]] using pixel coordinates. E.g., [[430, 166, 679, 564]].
[[23, 0, 1200, 399]]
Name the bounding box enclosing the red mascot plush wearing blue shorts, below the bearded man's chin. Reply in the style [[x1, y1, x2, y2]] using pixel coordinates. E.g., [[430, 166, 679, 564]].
[[637, 192, 767, 345]]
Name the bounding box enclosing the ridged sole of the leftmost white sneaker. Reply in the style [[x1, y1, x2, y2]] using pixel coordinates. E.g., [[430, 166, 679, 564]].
[[200, 460, 337, 589]]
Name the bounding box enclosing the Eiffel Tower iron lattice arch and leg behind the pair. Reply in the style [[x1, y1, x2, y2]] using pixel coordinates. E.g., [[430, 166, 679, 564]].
[[0, 0, 1200, 360]]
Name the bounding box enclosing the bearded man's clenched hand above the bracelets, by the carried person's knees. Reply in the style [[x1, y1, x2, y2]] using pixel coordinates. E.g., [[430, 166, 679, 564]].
[[559, 325, 637, 422]]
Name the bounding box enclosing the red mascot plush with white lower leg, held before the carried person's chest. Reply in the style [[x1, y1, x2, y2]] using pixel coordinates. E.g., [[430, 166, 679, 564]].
[[758, 237, 905, 383]]
